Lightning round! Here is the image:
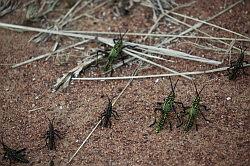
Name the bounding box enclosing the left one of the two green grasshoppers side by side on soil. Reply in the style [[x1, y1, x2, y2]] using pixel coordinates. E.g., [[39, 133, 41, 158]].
[[150, 77, 184, 133]]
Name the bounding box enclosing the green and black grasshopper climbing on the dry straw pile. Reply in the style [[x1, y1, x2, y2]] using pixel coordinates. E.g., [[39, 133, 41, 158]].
[[97, 30, 133, 76]]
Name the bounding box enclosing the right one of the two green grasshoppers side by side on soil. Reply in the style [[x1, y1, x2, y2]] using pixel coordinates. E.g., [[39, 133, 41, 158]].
[[184, 83, 210, 131]]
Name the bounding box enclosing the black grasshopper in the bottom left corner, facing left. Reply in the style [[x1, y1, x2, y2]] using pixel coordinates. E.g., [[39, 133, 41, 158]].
[[1, 138, 29, 165]]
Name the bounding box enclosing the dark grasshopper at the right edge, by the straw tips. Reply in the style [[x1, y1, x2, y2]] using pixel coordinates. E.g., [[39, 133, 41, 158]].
[[227, 48, 248, 80]]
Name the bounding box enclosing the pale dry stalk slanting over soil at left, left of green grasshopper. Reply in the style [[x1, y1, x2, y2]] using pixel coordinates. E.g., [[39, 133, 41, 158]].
[[12, 40, 89, 68]]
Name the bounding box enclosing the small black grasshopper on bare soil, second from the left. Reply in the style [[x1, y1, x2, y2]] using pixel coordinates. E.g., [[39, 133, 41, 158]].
[[44, 118, 62, 150]]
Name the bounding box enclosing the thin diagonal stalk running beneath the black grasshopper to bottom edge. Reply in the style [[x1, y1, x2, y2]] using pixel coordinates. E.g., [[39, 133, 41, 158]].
[[67, 66, 140, 164]]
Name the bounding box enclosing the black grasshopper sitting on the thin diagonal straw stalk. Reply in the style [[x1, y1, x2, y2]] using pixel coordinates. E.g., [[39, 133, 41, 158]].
[[100, 96, 118, 128]]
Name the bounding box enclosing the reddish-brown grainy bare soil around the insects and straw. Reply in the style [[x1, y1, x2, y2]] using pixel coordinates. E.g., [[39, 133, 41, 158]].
[[0, 0, 250, 166]]
